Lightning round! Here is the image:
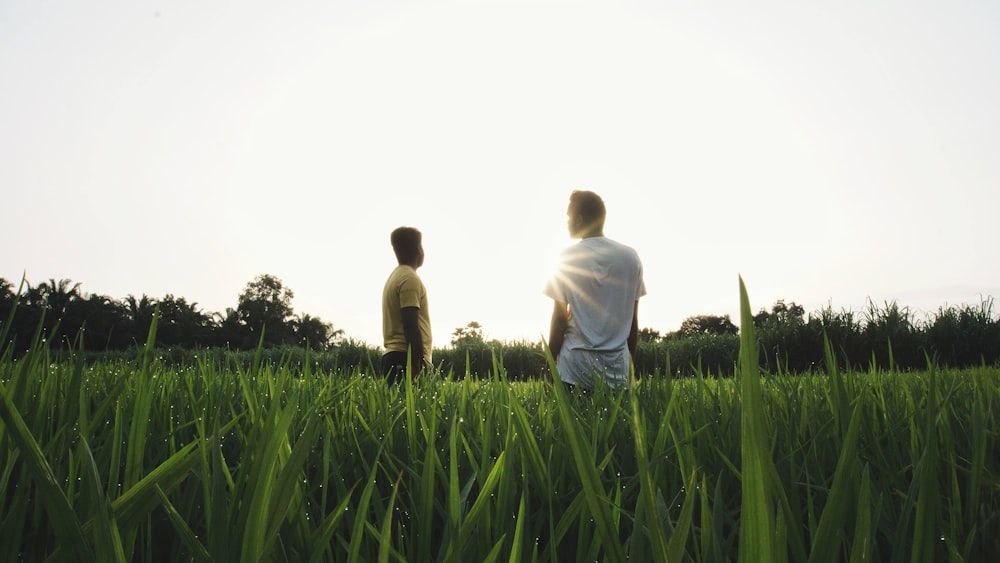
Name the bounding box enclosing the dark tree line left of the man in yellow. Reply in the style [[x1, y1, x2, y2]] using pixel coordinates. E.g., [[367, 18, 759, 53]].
[[0, 274, 344, 351]]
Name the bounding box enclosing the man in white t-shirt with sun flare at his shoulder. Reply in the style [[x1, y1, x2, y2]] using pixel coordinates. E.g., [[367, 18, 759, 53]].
[[545, 191, 646, 390]]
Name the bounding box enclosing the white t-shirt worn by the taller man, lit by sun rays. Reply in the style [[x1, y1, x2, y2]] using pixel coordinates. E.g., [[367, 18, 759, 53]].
[[545, 237, 646, 387]]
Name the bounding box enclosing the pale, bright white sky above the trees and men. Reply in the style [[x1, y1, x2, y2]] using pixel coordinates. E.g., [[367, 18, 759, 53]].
[[0, 0, 1000, 346]]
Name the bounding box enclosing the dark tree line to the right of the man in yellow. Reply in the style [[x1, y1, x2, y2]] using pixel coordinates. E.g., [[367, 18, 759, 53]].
[[446, 298, 1000, 379]]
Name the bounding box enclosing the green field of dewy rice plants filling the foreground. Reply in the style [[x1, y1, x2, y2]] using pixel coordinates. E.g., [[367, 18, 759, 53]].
[[0, 288, 1000, 562]]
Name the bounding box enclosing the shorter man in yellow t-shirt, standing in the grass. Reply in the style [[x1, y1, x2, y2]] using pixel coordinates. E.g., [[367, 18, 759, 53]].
[[380, 227, 433, 383]]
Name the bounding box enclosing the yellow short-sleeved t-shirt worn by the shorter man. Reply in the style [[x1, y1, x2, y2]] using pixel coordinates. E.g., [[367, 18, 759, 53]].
[[382, 265, 433, 366]]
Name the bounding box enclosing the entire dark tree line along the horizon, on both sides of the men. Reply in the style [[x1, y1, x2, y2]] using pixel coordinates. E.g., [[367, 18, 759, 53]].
[[0, 274, 1000, 380]]
